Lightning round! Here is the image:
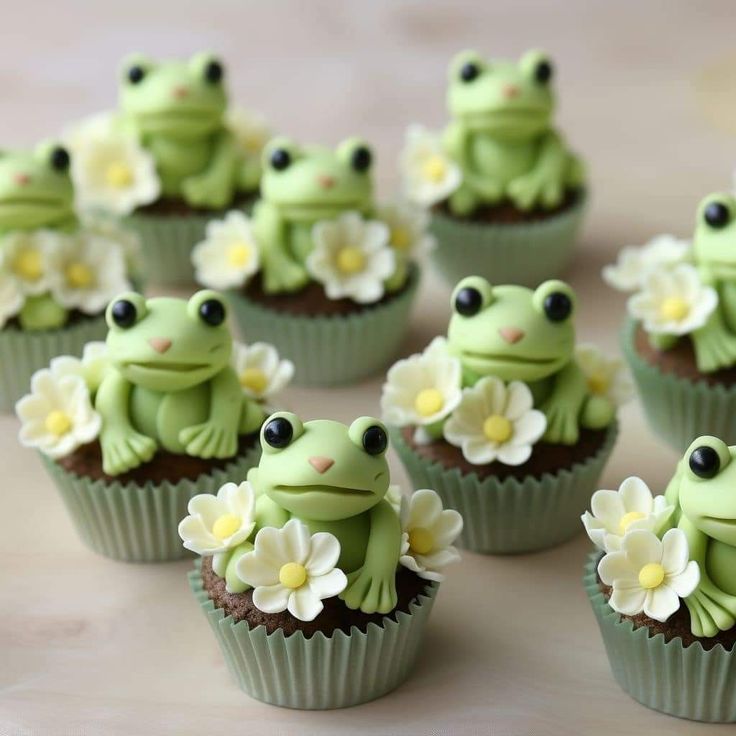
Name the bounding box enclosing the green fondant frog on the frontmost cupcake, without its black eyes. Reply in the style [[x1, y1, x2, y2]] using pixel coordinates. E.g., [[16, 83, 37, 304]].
[[248, 412, 401, 613]]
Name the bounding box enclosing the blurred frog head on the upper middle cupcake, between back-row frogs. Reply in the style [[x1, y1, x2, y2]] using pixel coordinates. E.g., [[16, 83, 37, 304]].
[[261, 137, 373, 221]]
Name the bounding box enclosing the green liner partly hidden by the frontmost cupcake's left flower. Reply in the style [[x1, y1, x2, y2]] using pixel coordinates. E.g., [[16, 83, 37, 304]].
[[41, 447, 260, 562]]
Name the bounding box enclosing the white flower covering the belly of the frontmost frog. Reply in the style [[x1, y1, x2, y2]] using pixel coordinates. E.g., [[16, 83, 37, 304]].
[[235, 519, 347, 621]]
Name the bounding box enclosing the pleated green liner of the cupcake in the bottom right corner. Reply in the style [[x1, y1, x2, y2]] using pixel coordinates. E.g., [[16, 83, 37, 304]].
[[583, 552, 736, 723]]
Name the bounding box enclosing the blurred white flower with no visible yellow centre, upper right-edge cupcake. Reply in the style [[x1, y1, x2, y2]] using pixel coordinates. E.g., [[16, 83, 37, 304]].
[[603, 235, 690, 291]]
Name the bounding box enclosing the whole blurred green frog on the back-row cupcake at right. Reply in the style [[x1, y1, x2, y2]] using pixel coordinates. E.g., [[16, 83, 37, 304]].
[[443, 51, 584, 215]]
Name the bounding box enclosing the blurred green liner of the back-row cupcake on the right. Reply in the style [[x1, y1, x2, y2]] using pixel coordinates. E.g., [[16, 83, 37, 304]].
[[430, 196, 587, 287]]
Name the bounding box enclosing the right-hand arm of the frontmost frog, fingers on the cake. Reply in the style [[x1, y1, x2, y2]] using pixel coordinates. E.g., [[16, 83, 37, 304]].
[[340, 499, 401, 613]]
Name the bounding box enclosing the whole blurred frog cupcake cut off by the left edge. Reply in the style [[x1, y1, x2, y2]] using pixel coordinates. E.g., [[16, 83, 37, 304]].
[[0, 142, 135, 411]]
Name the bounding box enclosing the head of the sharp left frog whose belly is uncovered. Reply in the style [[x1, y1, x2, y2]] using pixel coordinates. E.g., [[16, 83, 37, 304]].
[[106, 290, 232, 393]]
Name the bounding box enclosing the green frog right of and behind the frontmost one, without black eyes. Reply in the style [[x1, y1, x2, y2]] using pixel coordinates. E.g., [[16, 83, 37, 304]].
[[447, 276, 615, 445]]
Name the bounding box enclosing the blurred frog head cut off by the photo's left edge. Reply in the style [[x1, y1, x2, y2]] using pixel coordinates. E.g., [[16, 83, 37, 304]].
[[0, 141, 74, 231]]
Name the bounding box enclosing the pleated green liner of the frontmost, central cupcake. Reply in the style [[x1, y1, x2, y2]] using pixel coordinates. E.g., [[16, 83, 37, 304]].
[[189, 560, 439, 710]]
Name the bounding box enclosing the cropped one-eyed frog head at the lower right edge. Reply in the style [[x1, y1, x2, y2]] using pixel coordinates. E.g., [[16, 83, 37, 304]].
[[678, 436, 736, 547]]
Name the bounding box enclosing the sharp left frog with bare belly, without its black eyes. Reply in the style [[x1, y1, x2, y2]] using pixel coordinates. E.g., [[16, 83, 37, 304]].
[[95, 291, 263, 475]]
